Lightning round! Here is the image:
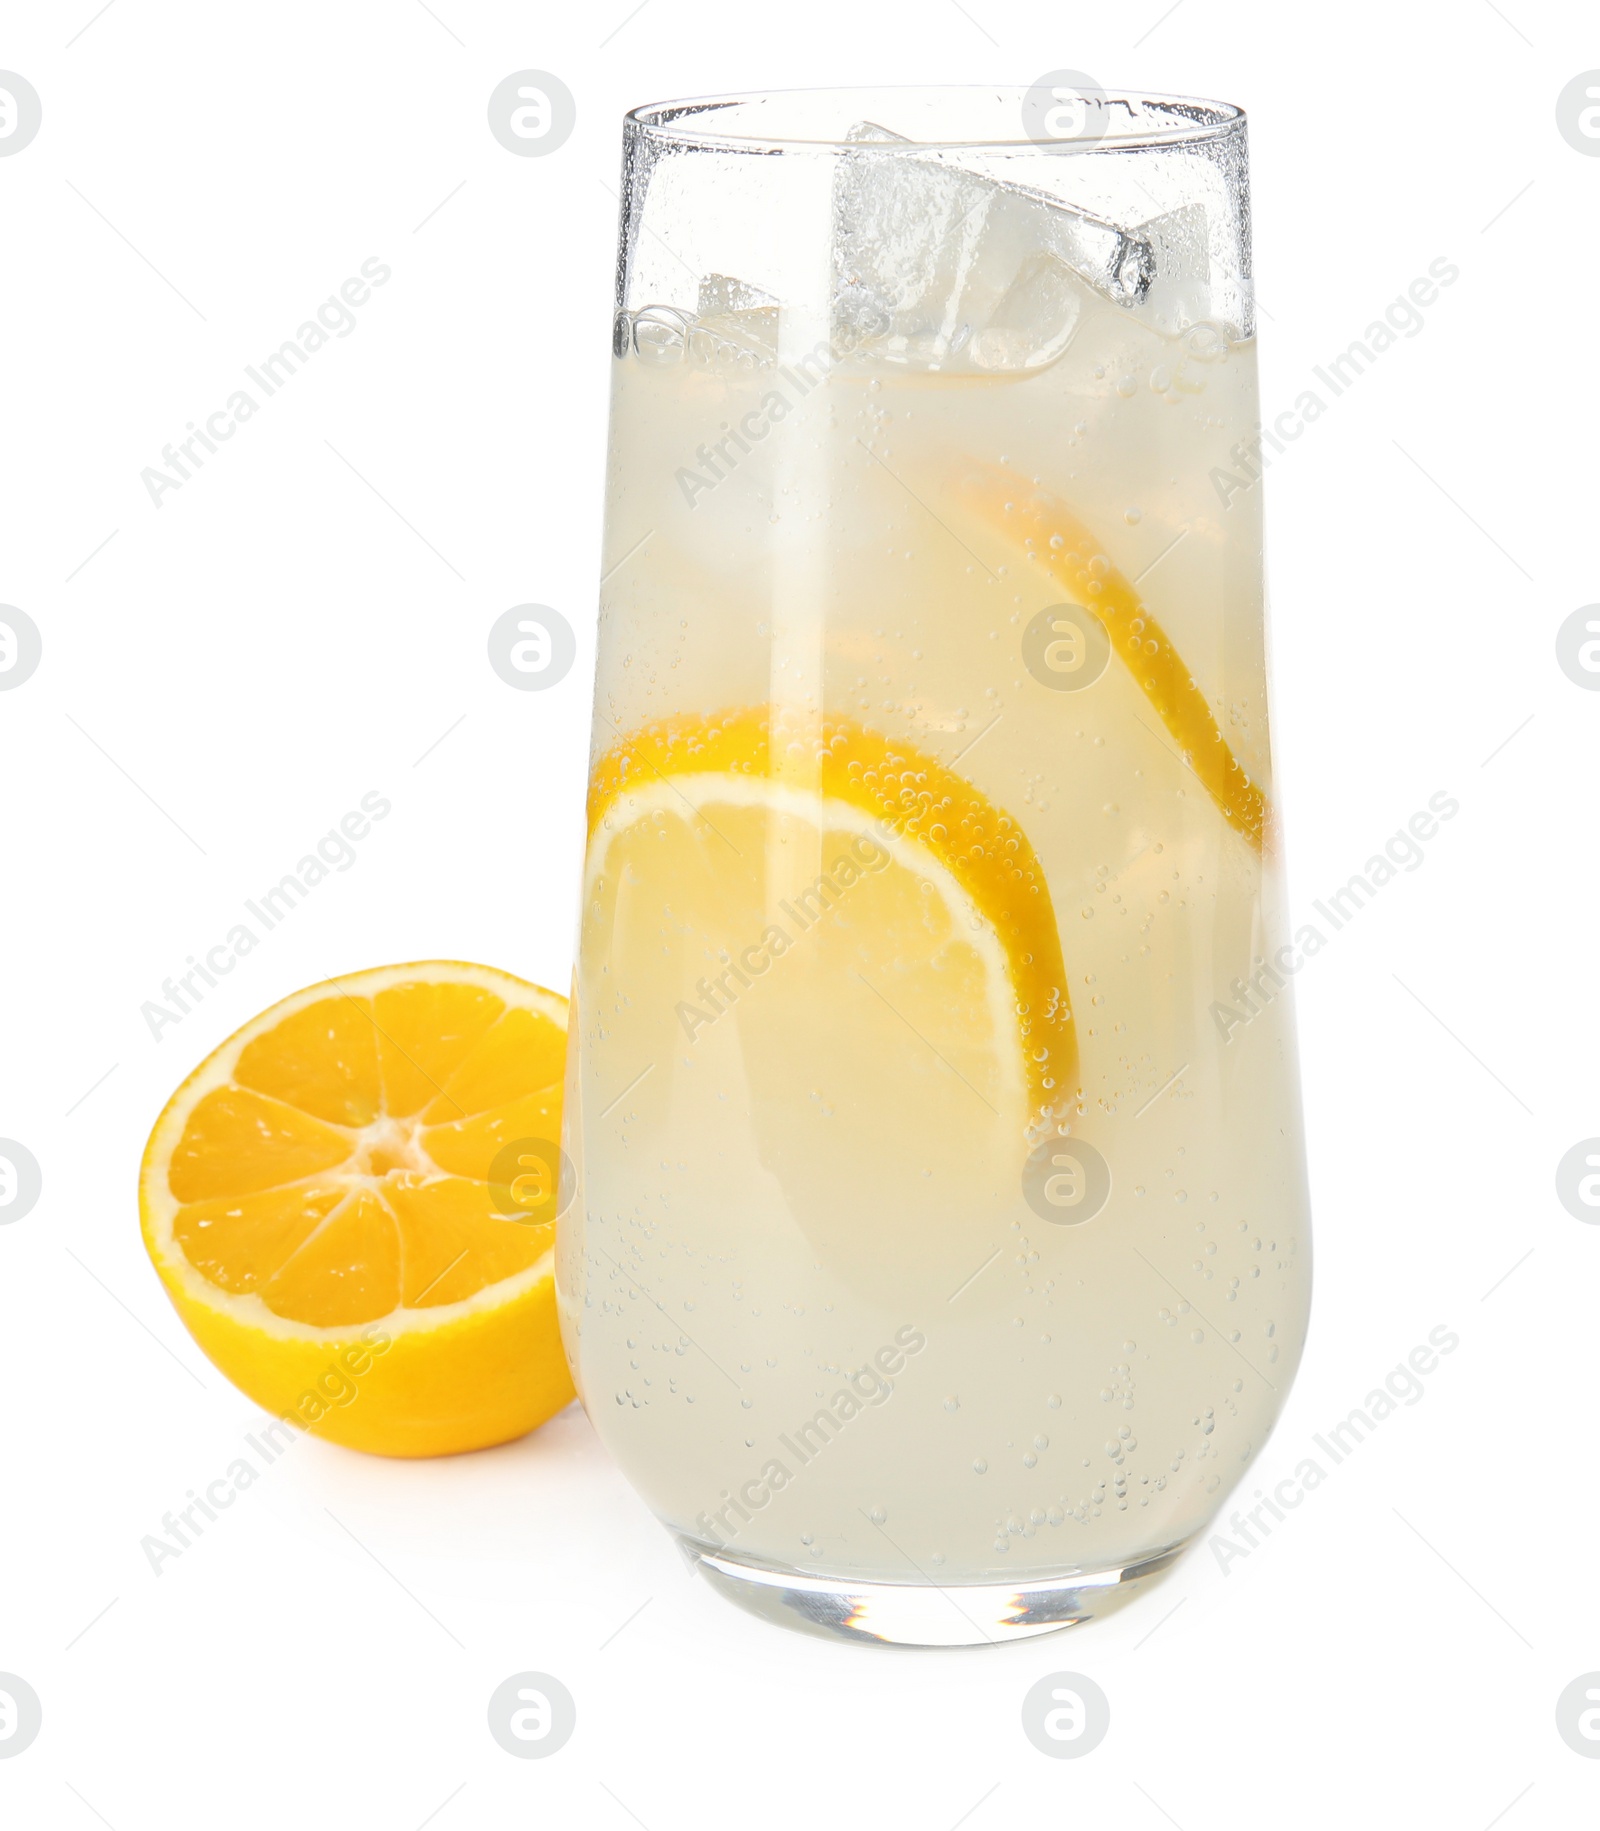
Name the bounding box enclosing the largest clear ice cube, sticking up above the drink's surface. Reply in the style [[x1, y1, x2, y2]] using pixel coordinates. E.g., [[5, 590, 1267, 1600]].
[[833, 123, 1159, 372]]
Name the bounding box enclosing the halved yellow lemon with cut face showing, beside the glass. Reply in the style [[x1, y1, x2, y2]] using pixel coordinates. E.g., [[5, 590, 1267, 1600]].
[[139, 961, 573, 1456]]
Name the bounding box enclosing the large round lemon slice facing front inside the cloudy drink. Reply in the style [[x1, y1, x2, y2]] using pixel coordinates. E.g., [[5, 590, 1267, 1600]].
[[584, 710, 1078, 1276]]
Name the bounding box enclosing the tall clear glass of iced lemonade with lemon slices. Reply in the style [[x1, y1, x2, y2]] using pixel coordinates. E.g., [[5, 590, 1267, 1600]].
[[558, 86, 1309, 1644]]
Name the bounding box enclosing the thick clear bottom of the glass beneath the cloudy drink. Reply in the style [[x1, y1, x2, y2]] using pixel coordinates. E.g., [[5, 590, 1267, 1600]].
[[674, 1533, 1188, 1646]]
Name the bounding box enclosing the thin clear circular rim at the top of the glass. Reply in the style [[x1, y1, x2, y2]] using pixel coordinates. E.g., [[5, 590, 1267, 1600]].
[[622, 82, 1247, 156]]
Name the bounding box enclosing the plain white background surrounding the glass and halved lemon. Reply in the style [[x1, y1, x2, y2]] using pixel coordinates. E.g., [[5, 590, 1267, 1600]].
[[0, 0, 1600, 1831]]
